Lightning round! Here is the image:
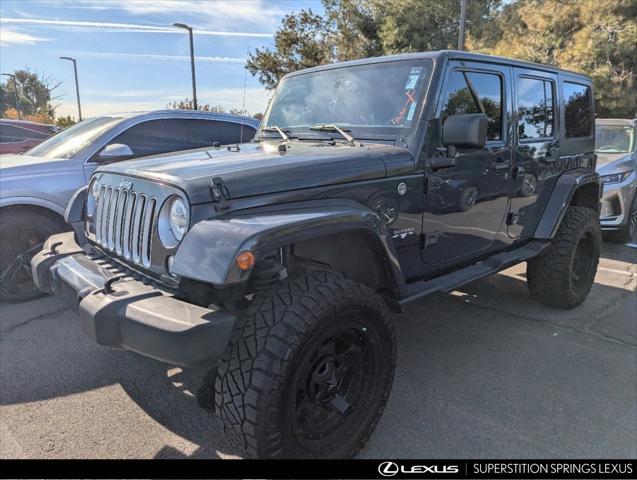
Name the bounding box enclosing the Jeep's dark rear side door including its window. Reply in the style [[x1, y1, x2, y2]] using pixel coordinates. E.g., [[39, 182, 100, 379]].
[[507, 68, 560, 238]]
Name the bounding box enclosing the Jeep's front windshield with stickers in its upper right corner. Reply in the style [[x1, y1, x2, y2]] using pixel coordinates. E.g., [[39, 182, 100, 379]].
[[262, 59, 432, 138]]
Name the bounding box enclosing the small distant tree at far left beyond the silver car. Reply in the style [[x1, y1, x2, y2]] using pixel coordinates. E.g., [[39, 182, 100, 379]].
[[0, 69, 62, 120]]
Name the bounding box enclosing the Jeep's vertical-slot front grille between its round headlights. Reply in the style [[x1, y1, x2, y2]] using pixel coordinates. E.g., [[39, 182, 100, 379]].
[[95, 185, 157, 267]]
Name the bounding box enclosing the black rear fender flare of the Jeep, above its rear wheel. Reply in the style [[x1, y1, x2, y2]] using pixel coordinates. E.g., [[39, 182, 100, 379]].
[[533, 168, 602, 240]]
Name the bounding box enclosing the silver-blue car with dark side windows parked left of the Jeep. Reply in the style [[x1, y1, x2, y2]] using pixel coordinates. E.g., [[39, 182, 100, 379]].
[[0, 110, 259, 301]]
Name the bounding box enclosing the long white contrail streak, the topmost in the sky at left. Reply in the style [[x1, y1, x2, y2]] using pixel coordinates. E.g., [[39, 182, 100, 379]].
[[0, 18, 272, 38]]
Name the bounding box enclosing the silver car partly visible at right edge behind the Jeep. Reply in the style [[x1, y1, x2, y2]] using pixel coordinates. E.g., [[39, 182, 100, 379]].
[[595, 118, 637, 244]]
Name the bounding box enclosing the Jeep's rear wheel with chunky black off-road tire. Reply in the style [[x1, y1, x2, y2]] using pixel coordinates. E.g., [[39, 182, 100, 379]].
[[526, 207, 602, 309]]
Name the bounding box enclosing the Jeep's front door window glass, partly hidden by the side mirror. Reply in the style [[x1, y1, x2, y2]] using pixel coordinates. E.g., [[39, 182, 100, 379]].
[[442, 70, 502, 140]]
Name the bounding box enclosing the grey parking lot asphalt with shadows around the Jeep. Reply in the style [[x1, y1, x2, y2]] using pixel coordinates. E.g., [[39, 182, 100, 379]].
[[0, 244, 637, 458]]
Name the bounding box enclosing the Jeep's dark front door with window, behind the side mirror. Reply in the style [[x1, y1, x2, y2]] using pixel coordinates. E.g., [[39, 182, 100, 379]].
[[422, 62, 512, 266]]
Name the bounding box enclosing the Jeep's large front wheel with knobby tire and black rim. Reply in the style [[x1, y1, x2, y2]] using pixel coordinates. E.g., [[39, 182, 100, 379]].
[[214, 272, 396, 458]]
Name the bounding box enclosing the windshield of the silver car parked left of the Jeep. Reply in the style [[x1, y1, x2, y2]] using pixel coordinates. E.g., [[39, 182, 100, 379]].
[[25, 117, 123, 158]]
